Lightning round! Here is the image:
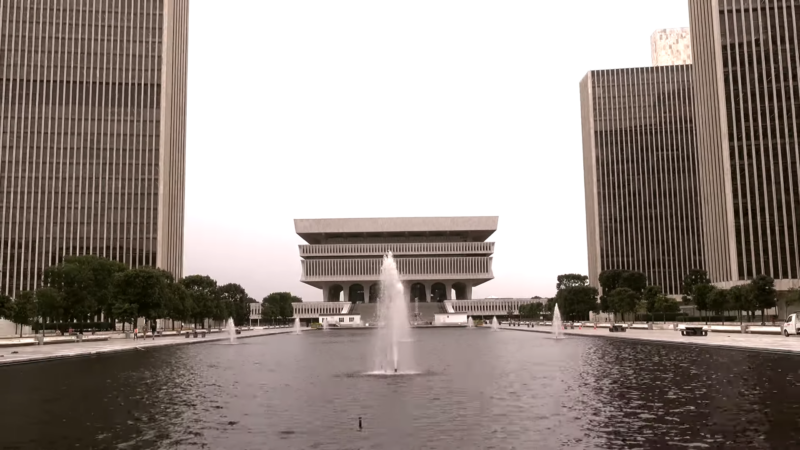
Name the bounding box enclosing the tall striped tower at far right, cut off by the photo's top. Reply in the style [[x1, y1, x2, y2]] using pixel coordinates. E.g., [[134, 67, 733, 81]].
[[689, 0, 800, 289]]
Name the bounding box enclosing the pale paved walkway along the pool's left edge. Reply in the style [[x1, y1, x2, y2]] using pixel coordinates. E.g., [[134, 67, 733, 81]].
[[0, 328, 304, 367]]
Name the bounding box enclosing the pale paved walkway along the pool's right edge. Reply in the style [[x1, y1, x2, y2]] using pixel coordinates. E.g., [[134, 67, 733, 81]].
[[501, 325, 800, 355]]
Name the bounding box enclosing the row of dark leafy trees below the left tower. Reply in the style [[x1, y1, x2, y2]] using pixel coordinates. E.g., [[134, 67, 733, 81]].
[[0, 256, 255, 334]]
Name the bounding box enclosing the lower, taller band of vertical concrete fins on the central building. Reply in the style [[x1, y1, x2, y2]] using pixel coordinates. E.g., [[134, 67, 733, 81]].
[[300, 256, 494, 281]]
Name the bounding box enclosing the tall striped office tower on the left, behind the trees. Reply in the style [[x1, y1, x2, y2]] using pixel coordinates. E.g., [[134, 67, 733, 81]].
[[0, 0, 189, 295]]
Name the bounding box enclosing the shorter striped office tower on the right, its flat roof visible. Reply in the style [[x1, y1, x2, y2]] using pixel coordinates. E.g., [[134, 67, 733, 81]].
[[580, 65, 703, 295]]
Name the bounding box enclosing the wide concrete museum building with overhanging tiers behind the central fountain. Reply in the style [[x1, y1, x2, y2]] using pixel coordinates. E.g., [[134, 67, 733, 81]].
[[295, 217, 498, 302]]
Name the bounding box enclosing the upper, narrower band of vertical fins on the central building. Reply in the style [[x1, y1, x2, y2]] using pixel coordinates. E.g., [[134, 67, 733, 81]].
[[299, 242, 494, 257]]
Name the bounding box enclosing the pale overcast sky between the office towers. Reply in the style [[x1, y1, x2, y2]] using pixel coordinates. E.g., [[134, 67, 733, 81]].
[[184, 0, 689, 301]]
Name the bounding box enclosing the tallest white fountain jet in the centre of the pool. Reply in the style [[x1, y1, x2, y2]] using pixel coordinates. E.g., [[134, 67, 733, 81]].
[[373, 252, 413, 374]]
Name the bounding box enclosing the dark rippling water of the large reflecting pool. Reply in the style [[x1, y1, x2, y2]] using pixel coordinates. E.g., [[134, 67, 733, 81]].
[[0, 329, 800, 449]]
